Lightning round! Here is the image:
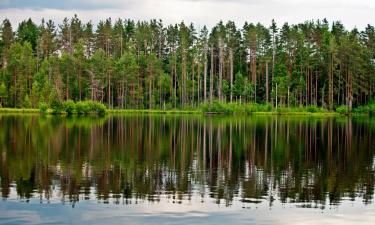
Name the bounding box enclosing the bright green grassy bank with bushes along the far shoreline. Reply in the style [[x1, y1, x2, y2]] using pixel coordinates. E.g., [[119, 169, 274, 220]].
[[0, 100, 375, 116]]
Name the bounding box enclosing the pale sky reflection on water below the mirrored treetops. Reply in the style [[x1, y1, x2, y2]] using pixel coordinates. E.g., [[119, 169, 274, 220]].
[[0, 185, 375, 225]]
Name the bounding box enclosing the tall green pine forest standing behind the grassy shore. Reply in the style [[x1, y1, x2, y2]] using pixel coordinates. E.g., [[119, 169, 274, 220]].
[[0, 15, 375, 110]]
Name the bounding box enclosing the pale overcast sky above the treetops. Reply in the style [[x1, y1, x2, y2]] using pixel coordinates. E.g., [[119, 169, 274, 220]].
[[0, 0, 375, 28]]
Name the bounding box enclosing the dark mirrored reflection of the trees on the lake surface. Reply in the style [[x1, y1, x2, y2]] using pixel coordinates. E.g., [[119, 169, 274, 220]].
[[0, 116, 375, 208]]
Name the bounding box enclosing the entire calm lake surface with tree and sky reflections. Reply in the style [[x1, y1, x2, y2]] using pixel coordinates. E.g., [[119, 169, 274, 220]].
[[0, 115, 375, 224]]
